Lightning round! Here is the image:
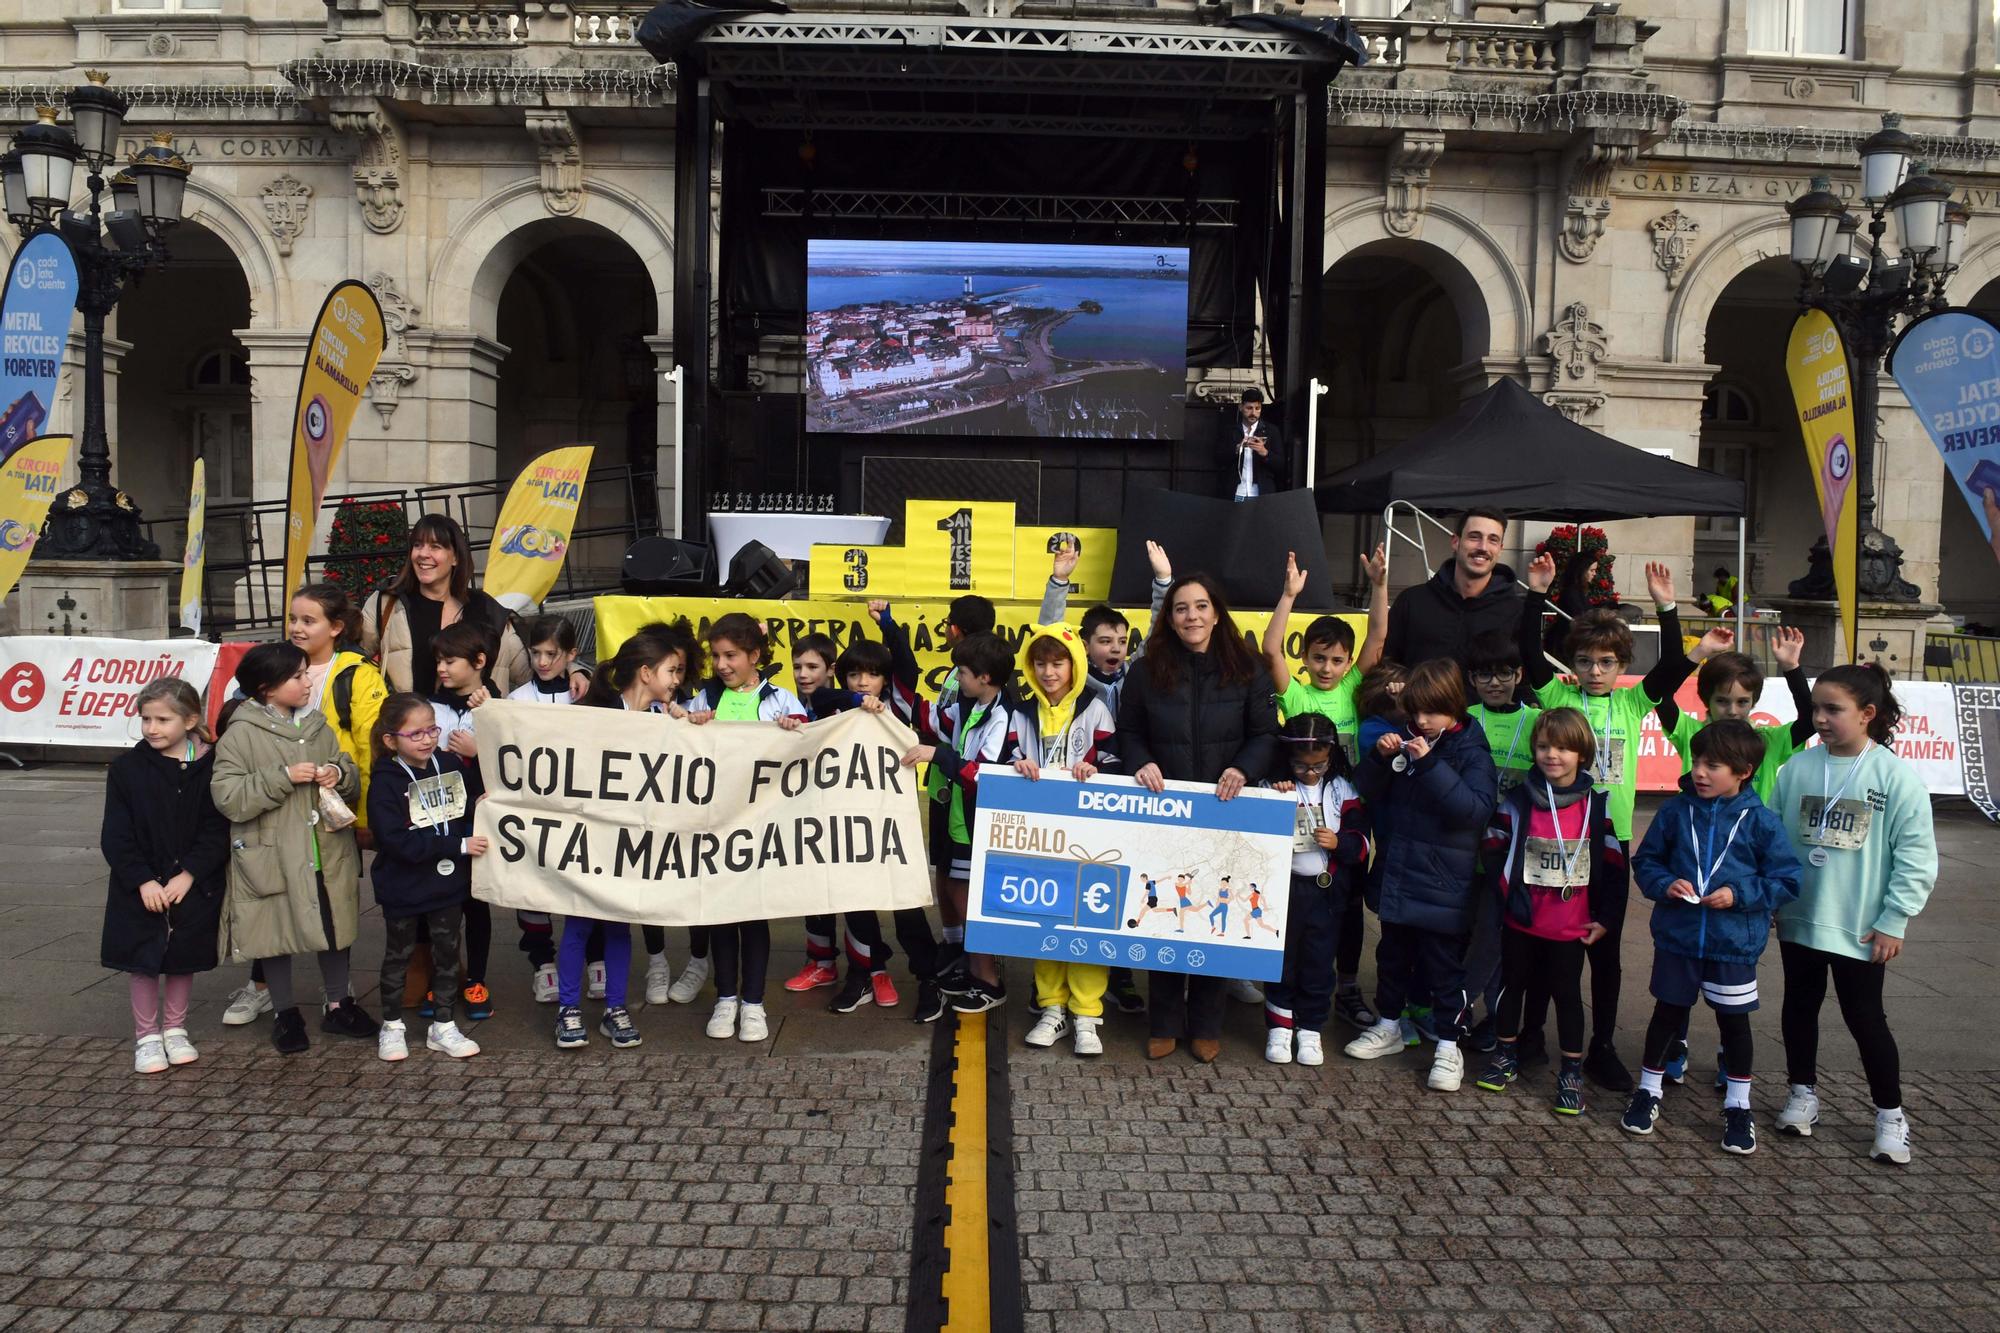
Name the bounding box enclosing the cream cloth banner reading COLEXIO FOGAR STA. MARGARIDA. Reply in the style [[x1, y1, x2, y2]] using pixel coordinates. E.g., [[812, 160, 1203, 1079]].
[[472, 701, 932, 925]]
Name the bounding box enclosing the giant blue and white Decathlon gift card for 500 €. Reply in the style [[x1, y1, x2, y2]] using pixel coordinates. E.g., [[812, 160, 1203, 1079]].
[[966, 765, 1296, 981]]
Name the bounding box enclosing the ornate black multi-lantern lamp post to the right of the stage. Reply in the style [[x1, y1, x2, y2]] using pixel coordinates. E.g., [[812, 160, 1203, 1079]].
[[1784, 114, 1972, 602]]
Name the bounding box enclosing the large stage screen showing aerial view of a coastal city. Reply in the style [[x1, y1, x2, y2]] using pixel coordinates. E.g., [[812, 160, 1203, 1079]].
[[806, 240, 1188, 440]]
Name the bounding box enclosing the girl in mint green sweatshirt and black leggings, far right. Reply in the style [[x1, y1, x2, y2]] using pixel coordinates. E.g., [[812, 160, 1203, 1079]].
[[1774, 662, 1938, 1165]]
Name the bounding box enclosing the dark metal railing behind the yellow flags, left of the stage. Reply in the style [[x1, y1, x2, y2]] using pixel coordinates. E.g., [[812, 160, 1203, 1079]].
[[144, 466, 660, 634]]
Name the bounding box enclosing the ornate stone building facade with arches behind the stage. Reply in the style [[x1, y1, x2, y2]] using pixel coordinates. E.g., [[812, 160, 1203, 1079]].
[[0, 0, 2000, 622]]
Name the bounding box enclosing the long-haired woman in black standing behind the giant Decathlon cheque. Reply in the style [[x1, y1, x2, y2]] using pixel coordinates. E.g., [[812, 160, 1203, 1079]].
[[1118, 574, 1278, 1063]]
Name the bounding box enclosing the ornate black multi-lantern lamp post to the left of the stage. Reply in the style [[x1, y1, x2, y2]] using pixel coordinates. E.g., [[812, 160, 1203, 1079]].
[[0, 70, 188, 560]]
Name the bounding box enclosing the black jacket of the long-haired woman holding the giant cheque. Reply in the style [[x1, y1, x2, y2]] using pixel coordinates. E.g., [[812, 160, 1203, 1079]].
[[1118, 652, 1278, 783]]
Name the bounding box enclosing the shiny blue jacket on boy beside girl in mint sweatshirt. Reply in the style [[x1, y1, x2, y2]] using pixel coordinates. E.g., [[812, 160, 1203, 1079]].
[[1632, 783, 1800, 963]]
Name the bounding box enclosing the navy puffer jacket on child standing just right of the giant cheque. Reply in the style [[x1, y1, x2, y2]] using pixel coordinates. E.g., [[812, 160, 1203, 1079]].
[[1354, 723, 1500, 935]]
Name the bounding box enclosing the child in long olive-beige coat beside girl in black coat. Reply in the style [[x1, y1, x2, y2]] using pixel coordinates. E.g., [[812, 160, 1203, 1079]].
[[210, 642, 376, 1055]]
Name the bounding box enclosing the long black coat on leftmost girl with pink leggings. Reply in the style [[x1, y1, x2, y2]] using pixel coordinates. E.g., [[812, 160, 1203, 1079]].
[[98, 741, 230, 977]]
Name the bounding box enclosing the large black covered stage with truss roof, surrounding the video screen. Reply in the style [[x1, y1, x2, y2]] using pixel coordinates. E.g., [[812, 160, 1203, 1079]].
[[638, 0, 1362, 530]]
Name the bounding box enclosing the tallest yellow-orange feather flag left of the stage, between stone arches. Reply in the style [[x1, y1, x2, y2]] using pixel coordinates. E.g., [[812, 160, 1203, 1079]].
[[284, 278, 382, 596]]
